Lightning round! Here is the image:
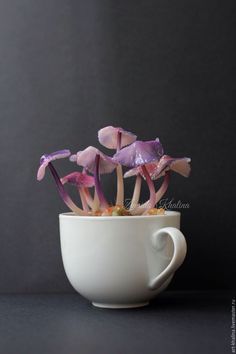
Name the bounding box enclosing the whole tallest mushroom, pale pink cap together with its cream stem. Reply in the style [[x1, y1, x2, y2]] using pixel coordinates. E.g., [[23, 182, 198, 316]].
[[98, 126, 137, 206]]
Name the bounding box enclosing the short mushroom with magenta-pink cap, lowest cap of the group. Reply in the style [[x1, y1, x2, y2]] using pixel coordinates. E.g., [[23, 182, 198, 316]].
[[61, 172, 95, 211]]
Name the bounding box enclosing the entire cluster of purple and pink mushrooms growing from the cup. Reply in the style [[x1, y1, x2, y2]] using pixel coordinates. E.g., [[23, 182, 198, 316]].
[[37, 126, 191, 216]]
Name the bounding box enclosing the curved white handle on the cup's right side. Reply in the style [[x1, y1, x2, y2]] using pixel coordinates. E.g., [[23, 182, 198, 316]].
[[149, 227, 187, 290]]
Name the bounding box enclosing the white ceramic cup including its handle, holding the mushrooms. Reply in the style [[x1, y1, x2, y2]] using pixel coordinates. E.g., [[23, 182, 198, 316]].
[[59, 211, 186, 308]]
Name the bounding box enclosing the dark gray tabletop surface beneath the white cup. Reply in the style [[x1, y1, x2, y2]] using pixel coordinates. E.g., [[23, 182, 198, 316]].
[[0, 292, 232, 354]]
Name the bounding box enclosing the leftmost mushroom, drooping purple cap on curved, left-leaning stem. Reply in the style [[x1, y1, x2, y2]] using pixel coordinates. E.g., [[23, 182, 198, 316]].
[[37, 150, 87, 215]]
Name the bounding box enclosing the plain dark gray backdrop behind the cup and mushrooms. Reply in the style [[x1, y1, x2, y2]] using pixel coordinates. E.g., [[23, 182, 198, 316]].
[[0, 0, 236, 292]]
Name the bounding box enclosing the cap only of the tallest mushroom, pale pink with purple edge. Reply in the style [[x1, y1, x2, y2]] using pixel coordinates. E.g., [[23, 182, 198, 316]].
[[98, 125, 137, 149]]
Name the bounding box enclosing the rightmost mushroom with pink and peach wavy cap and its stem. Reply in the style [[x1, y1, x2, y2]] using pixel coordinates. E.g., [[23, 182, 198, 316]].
[[138, 155, 191, 210]]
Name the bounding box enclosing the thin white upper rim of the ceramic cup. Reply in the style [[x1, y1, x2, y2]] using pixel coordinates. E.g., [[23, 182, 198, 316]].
[[59, 210, 181, 220]]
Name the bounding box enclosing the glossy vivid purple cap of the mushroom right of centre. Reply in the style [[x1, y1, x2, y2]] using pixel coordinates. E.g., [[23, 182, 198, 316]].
[[113, 138, 163, 168]]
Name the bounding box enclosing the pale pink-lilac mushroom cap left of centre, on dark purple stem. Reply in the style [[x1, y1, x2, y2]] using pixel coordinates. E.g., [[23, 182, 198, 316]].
[[72, 146, 117, 174]]
